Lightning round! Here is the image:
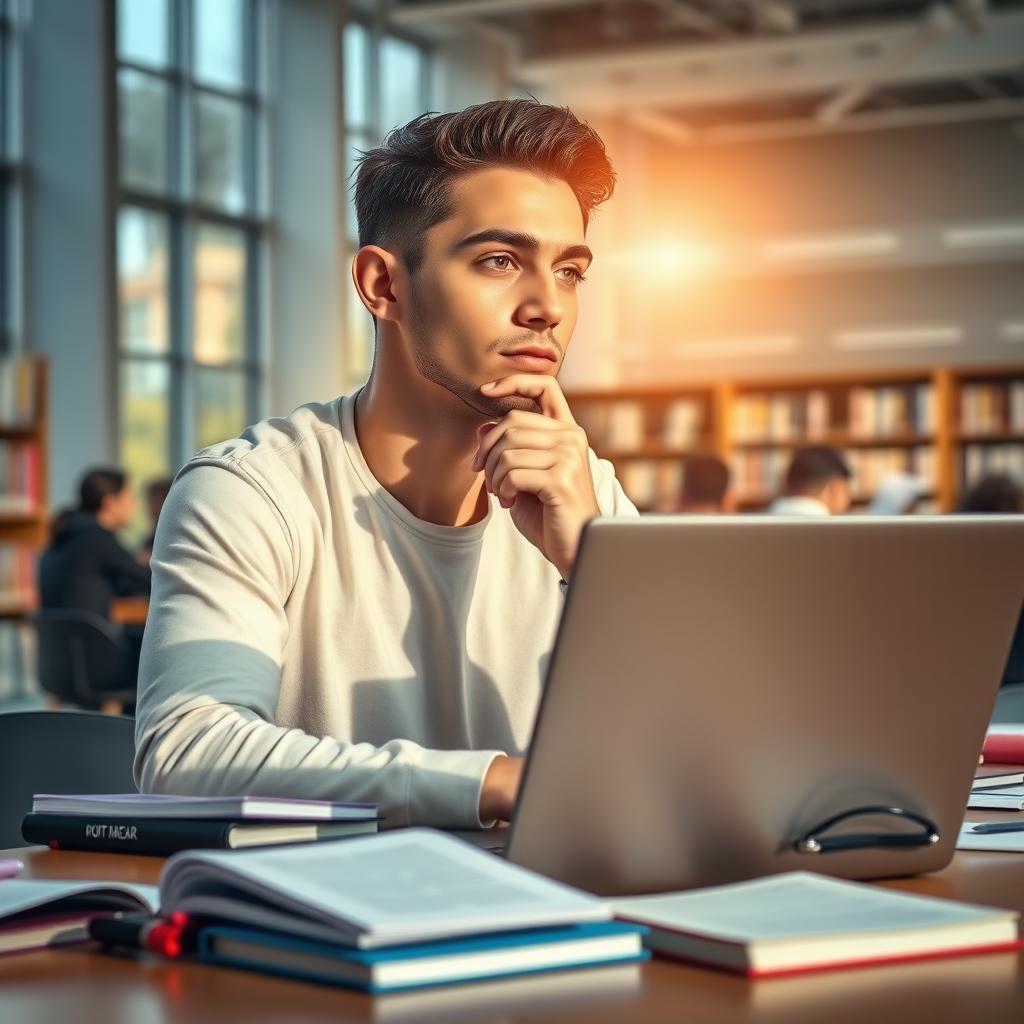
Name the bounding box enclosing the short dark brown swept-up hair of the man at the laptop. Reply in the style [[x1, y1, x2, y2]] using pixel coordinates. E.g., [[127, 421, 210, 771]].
[[355, 99, 615, 270]]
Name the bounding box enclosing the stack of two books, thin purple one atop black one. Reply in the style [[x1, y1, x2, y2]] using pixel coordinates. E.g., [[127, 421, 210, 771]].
[[22, 793, 378, 856]]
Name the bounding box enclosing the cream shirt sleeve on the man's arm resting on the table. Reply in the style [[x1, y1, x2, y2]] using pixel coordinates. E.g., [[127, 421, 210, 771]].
[[134, 463, 497, 827]]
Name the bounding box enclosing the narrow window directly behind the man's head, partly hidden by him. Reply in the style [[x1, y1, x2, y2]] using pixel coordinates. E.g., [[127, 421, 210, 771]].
[[342, 22, 431, 387]]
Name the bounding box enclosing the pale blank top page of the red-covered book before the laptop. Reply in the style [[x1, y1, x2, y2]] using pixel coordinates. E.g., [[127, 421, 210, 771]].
[[613, 871, 1005, 942]]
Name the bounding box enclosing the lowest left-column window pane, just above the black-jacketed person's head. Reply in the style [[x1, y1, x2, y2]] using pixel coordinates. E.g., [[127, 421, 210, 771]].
[[121, 359, 171, 484]]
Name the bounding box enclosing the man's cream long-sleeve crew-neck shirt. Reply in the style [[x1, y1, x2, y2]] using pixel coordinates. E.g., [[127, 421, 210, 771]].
[[135, 395, 636, 827]]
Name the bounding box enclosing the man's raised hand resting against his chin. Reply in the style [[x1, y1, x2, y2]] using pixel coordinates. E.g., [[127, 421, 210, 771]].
[[473, 374, 600, 580]]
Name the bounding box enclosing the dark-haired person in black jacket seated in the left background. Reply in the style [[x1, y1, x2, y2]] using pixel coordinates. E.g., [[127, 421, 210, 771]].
[[39, 468, 151, 708]]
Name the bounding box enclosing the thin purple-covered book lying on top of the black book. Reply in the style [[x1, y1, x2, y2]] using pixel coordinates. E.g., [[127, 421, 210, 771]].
[[32, 793, 378, 821]]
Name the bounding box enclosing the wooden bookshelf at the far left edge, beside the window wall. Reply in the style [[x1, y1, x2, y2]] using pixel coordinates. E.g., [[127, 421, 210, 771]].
[[0, 356, 49, 618]]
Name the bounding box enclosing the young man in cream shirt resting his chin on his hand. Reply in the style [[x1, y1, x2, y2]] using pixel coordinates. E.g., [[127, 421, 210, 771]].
[[136, 100, 635, 827]]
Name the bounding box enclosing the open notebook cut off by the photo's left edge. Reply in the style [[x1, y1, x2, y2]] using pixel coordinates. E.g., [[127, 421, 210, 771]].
[[0, 879, 160, 953]]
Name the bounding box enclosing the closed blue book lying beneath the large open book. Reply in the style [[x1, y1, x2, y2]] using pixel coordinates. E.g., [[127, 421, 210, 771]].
[[197, 921, 650, 993]]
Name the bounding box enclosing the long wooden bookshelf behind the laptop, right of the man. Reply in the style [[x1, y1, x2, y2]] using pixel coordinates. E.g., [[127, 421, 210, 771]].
[[566, 364, 1024, 511]]
